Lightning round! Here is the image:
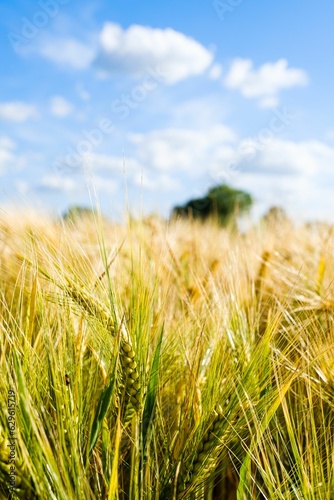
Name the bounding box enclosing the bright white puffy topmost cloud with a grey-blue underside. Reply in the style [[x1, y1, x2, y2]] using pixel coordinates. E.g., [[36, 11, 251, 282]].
[[96, 23, 213, 84]]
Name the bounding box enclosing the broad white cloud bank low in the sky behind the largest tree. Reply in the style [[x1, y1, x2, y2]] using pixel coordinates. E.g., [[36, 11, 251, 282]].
[[92, 124, 334, 218]]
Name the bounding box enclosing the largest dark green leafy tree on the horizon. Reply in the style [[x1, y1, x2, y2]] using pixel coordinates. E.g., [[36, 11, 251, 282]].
[[173, 184, 253, 224]]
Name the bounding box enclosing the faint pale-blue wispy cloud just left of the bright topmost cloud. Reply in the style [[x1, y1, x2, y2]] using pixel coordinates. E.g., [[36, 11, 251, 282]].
[[37, 37, 96, 70]]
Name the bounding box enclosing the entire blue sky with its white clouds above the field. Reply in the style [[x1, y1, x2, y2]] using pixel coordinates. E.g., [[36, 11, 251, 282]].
[[0, 0, 334, 220]]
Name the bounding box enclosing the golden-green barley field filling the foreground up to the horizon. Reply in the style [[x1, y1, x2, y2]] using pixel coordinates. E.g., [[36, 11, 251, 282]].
[[0, 214, 334, 500]]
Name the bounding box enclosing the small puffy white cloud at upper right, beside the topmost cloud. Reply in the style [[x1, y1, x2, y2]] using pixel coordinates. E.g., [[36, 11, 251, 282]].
[[224, 59, 308, 108]]
